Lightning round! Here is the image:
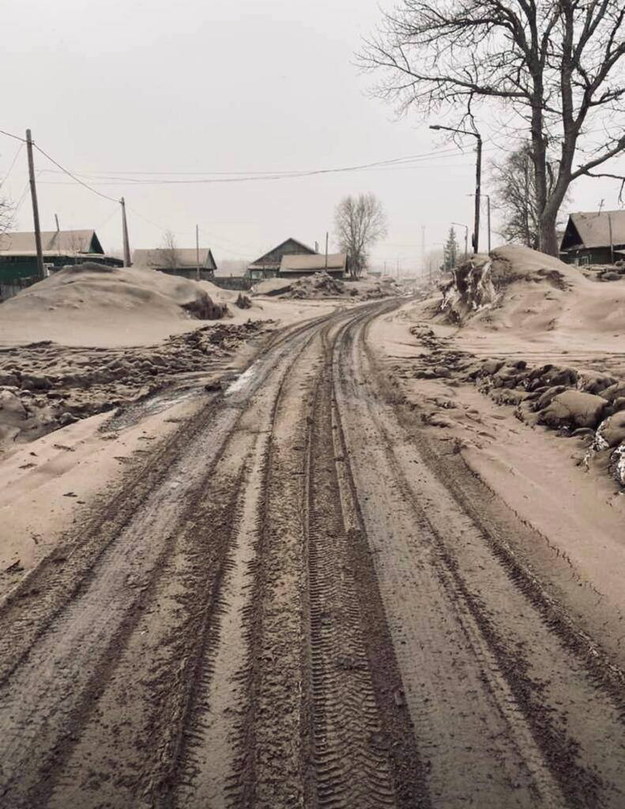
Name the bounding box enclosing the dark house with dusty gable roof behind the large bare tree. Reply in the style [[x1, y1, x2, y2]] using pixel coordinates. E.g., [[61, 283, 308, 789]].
[[560, 211, 625, 264]]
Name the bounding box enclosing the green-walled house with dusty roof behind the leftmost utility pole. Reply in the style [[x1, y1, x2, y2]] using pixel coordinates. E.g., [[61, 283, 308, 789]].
[[0, 230, 124, 300]]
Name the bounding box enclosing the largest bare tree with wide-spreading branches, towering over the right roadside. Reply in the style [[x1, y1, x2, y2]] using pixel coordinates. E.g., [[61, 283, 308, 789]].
[[362, 0, 625, 255]]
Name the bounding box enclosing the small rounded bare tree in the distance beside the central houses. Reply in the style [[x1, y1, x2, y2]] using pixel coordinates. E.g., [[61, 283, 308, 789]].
[[334, 194, 386, 278]]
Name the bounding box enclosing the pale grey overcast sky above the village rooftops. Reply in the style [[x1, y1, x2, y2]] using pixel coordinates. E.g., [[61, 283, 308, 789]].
[[0, 0, 618, 271]]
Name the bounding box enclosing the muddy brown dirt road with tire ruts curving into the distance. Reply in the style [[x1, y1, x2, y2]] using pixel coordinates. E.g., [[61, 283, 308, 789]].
[[0, 301, 625, 809]]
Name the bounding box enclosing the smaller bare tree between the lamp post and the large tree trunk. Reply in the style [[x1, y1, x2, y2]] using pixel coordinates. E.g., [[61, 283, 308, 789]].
[[491, 142, 568, 250]]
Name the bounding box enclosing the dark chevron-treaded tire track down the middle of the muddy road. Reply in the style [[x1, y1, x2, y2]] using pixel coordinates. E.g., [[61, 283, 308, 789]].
[[306, 359, 396, 809]]
